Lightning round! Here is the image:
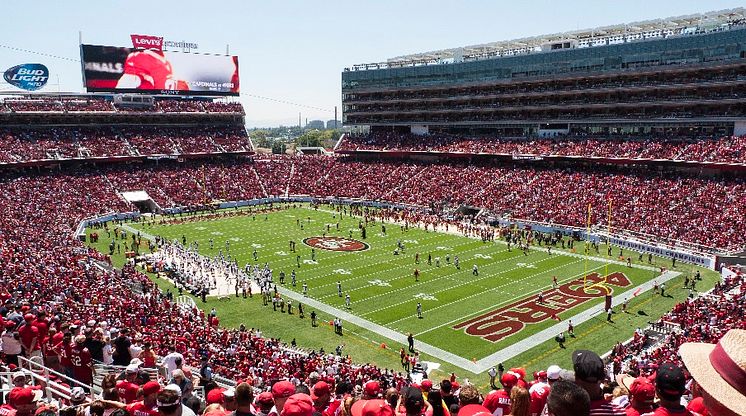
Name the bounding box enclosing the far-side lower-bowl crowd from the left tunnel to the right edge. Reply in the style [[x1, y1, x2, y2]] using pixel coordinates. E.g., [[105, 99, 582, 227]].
[[17, 154, 732, 250]]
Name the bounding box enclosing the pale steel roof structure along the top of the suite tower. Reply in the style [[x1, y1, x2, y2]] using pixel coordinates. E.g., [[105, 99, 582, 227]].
[[346, 7, 746, 70]]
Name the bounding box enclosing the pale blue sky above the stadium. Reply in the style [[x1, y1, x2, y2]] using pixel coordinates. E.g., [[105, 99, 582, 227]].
[[0, 0, 743, 127]]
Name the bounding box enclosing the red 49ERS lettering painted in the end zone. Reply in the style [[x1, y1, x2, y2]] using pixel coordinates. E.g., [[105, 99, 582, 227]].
[[453, 272, 631, 342]]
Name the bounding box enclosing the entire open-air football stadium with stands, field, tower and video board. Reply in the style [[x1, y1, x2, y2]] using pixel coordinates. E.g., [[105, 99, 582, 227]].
[[0, 8, 746, 416]]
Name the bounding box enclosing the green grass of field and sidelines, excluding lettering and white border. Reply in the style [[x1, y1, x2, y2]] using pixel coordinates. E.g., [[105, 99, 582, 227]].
[[84, 206, 716, 390]]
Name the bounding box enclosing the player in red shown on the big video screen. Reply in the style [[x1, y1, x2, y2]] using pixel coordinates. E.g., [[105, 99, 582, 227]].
[[117, 49, 183, 90]]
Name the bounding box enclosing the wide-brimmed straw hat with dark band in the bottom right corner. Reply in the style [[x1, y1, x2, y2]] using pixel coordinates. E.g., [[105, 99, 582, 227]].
[[679, 329, 746, 416]]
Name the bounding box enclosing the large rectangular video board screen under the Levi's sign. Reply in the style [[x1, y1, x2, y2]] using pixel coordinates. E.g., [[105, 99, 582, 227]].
[[80, 45, 239, 96]]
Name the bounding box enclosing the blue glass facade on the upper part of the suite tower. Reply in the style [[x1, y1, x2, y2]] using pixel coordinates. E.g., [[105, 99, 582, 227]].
[[342, 28, 746, 92]]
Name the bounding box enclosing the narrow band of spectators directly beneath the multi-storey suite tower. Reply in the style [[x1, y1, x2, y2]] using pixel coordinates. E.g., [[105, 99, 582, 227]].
[[336, 133, 746, 163]]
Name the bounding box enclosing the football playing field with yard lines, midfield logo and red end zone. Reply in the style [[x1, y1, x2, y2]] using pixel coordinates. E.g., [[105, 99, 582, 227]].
[[116, 206, 660, 368]]
